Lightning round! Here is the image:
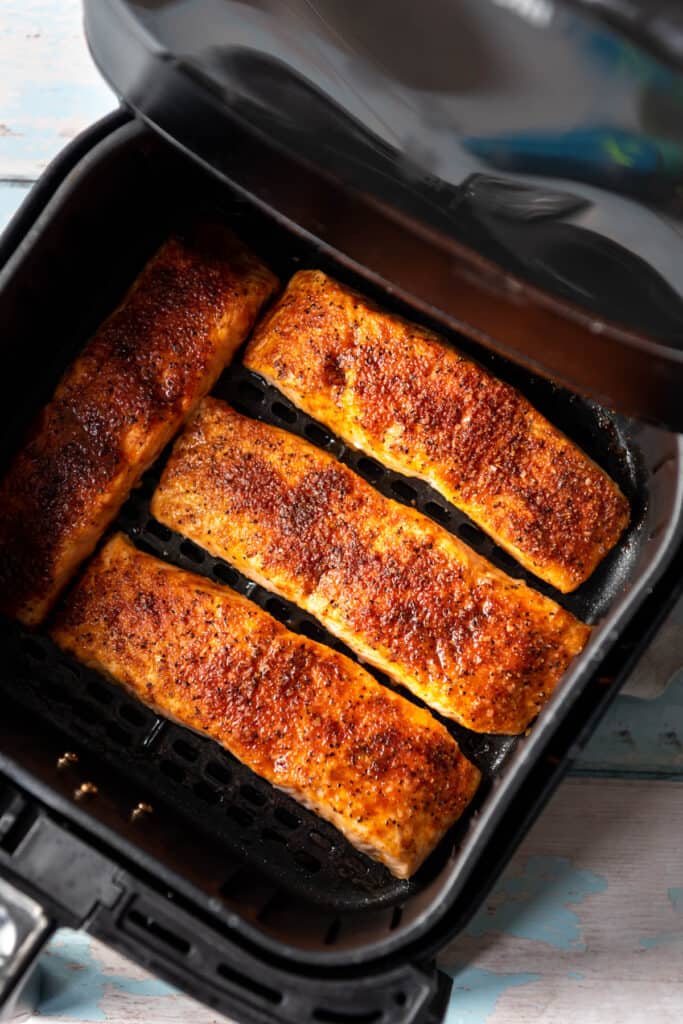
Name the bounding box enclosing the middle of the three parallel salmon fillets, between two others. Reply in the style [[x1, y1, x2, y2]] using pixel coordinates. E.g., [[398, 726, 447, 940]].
[[152, 398, 590, 733]]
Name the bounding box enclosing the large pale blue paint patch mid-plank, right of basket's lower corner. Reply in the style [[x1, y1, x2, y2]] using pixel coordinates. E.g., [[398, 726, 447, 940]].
[[466, 856, 607, 951]]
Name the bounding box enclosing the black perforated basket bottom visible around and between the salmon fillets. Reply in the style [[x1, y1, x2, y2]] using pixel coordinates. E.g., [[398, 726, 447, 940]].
[[4, 339, 642, 914]]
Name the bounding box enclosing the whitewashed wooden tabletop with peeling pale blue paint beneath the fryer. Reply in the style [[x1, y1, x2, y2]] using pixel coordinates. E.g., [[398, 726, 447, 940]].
[[0, 0, 683, 1024]]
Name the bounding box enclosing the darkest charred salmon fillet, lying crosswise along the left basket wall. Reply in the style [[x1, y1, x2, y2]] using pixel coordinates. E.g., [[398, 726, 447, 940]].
[[0, 225, 278, 626]]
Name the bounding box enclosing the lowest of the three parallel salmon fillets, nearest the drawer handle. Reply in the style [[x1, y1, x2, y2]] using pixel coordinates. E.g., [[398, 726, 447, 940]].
[[51, 535, 480, 879]]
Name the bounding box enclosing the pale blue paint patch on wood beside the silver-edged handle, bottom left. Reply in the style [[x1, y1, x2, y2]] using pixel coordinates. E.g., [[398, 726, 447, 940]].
[[38, 929, 175, 1021]]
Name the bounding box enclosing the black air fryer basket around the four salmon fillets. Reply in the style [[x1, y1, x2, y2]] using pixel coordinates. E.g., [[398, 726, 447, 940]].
[[0, 114, 683, 1019]]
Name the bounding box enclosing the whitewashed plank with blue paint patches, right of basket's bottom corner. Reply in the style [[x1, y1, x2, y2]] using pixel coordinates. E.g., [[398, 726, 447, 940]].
[[441, 779, 683, 1024]]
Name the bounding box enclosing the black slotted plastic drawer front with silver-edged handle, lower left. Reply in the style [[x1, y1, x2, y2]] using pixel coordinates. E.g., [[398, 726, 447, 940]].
[[0, 774, 451, 1024]]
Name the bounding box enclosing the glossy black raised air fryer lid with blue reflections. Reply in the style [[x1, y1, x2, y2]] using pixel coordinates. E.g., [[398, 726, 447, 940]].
[[85, 0, 683, 431]]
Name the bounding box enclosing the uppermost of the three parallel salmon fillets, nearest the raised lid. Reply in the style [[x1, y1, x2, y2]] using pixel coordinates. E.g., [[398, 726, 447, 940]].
[[245, 270, 629, 592]]
